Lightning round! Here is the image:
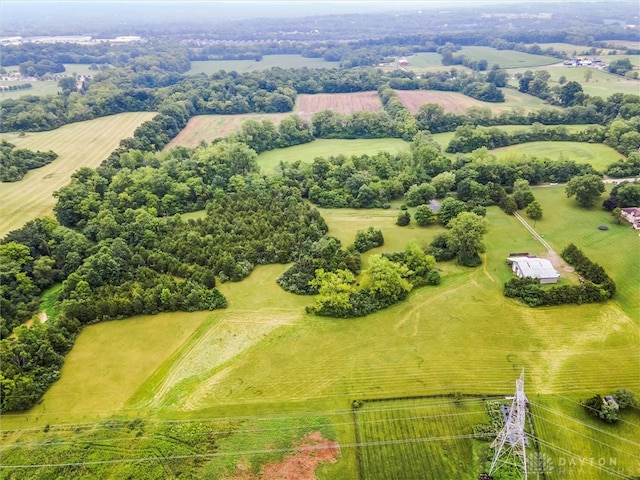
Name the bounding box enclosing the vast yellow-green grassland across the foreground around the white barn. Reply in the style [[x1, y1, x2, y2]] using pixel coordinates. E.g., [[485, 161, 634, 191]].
[[2, 193, 640, 480]]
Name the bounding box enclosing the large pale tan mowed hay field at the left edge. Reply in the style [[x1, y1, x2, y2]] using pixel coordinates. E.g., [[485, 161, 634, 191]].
[[0, 112, 155, 236]]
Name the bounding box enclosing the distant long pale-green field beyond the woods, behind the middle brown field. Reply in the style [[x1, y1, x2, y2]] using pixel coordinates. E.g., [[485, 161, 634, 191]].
[[187, 55, 338, 75]]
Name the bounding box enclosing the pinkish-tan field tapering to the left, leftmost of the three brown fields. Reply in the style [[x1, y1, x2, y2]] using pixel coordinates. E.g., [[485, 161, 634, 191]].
[[165, 113, 291, 150]]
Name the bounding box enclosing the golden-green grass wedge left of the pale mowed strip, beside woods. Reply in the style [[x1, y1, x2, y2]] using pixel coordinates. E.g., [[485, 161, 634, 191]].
[[2, 312, 211, 428]]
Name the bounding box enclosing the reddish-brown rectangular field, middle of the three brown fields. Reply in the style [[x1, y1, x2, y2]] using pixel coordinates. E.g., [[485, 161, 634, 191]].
[[295, 92, 382, 120]]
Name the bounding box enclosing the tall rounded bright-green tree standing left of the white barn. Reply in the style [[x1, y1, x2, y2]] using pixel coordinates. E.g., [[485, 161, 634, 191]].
[[449, 212, 489, 267]]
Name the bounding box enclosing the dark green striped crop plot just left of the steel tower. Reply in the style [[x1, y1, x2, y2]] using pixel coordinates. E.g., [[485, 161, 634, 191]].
[[355, 398, 487, 480]]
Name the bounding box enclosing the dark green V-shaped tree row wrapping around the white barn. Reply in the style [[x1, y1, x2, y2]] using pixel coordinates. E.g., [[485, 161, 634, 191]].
[[504, 244, 616, 307]]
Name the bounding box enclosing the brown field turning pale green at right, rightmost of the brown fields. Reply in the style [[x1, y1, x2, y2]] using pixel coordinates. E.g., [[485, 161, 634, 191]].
[[396, 90, 551, 114]]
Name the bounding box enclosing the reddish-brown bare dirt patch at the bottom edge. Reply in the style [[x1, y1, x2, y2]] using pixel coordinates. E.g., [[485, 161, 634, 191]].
[[225, 432, 340, 480]]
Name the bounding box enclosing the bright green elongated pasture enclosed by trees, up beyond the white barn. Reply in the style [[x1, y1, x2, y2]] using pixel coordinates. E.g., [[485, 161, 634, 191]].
[[491, 141, 624, 171]]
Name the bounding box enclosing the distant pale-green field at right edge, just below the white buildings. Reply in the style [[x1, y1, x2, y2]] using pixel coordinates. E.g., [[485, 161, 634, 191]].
[[509, 66, 640, 98]]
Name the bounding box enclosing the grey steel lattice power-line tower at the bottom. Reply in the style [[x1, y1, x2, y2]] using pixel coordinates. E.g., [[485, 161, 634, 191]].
[[489, 368, 528, 480]]
